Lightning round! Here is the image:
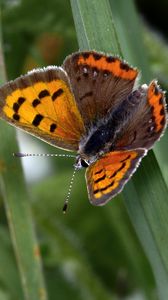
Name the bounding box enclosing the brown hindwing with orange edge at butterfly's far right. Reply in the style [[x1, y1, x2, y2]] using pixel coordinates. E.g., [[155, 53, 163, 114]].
[[115, 81, 167, 150]]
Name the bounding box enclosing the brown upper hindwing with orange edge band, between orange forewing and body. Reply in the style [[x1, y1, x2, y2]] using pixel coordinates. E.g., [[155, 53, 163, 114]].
[[63, 51, 138, 126]]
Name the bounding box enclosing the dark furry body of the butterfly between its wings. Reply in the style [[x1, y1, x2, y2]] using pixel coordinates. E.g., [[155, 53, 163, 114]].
[[75, 85, 147, 166]]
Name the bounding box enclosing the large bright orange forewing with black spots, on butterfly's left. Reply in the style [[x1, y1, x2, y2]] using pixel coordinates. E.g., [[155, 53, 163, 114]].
[[0, 67, 85, 150]]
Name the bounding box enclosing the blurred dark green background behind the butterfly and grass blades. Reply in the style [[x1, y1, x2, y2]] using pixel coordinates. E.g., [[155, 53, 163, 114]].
[[0, 0, 168, 300]]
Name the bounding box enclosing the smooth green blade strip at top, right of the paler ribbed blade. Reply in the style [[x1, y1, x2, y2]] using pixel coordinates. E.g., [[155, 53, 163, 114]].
[[109, 0, 151, 81]]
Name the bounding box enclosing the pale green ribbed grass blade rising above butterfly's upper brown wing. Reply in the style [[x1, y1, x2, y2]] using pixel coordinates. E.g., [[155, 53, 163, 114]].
[[71, 0, 121, 55]]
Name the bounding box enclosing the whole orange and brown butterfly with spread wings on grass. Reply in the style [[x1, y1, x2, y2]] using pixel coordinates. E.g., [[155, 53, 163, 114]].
[[0, 51, 167, 205]]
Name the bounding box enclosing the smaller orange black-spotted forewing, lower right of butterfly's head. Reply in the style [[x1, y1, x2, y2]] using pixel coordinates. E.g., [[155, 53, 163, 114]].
[[86, 149, 146, 205]]
